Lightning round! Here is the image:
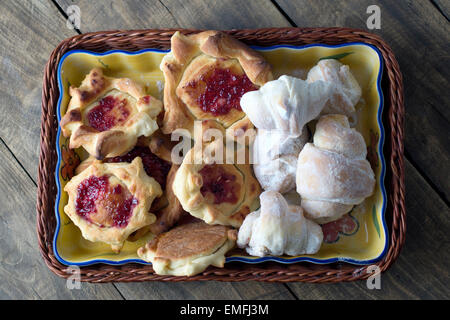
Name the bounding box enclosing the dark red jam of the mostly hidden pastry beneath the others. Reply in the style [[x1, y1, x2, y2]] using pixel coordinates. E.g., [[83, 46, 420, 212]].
[[105, 146, 170, 189]]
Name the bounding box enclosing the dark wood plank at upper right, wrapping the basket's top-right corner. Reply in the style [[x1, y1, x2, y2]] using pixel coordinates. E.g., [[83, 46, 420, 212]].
[[276, 0, 450, 203]]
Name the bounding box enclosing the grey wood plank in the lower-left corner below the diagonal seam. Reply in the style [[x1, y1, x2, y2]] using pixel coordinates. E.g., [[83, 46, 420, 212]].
[[0, 140, 122, 300]]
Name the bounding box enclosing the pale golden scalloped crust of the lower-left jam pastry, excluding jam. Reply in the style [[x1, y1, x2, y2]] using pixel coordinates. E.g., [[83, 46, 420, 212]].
[[64, 157, 162, 252]]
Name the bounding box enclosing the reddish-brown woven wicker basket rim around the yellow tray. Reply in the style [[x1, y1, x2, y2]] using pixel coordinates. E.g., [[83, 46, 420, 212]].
[[37, 28, 406, 283]]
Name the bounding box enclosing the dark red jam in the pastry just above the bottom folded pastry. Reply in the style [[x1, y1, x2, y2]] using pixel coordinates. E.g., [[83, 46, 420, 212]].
[[199, 165, 240, 204]]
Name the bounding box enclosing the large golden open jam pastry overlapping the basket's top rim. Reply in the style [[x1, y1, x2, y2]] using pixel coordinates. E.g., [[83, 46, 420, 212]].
[[161, 31, 272, 137]]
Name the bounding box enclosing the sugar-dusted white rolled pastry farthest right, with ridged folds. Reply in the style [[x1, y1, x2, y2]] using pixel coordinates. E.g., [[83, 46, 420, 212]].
[[296, 115, 375, 224]]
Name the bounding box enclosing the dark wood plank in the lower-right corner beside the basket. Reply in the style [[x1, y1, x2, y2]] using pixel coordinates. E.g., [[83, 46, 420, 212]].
[[289, 161, 450, 299]]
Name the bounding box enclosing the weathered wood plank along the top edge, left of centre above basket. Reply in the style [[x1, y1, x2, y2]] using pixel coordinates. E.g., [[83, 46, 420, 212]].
[[57, 0, 288, 32]]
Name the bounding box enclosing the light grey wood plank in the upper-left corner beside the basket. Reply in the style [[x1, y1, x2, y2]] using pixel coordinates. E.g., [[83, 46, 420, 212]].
[[0, 1, 76, 177]]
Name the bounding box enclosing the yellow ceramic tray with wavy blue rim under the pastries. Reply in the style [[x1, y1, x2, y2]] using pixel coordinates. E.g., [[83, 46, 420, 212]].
[[53, 43, 388, 266]]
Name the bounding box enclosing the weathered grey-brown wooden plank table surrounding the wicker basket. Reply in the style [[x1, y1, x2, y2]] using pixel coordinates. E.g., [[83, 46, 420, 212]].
[[0, 0, 450, 299]]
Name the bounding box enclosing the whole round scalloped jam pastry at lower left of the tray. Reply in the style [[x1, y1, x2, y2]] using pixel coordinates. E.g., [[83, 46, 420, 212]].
[[64, 157, 162, 252]]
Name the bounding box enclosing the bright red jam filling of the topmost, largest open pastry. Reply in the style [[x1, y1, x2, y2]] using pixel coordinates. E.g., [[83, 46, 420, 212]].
[[197, 69, 258, 116]]
